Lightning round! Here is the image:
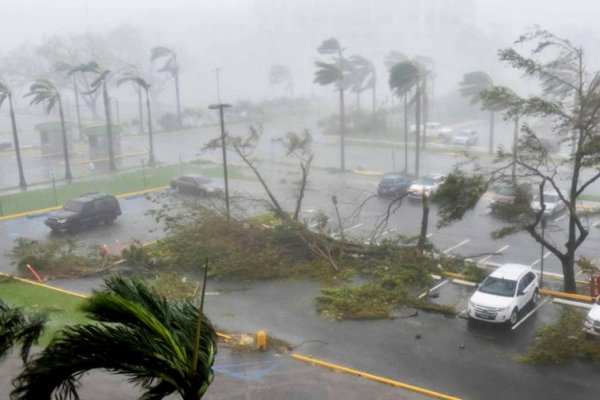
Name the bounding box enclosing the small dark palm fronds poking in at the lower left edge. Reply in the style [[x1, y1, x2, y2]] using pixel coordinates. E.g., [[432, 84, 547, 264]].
[[0, 300, 48, 362]]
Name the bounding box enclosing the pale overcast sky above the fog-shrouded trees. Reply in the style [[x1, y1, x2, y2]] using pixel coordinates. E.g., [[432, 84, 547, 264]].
[[0, 0, 600, 104]]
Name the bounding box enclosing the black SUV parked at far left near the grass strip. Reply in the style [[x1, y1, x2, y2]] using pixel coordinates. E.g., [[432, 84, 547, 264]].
[[44, 193, 121, 232]]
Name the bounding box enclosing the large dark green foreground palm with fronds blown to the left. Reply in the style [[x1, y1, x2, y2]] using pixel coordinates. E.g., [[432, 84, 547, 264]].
[[11, 276, 217, 400]]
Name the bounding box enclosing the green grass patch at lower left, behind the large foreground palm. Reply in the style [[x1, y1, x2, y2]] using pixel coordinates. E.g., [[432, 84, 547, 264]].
[[0, 279, 90, 346]]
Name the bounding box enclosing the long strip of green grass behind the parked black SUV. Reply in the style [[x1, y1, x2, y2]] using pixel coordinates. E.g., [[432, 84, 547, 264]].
[[0, 159, 243, 215]]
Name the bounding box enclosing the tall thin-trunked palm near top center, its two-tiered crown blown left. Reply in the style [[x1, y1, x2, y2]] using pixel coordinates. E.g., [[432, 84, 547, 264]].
[[313, 38, 349, 171]]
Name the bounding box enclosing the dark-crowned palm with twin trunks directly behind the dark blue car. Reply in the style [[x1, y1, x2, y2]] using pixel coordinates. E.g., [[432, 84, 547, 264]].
[[388, 61, 422, 178]]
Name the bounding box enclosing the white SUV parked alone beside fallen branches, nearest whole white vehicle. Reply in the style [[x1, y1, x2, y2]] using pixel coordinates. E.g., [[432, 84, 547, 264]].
[[467, 264, 539, 325]]
